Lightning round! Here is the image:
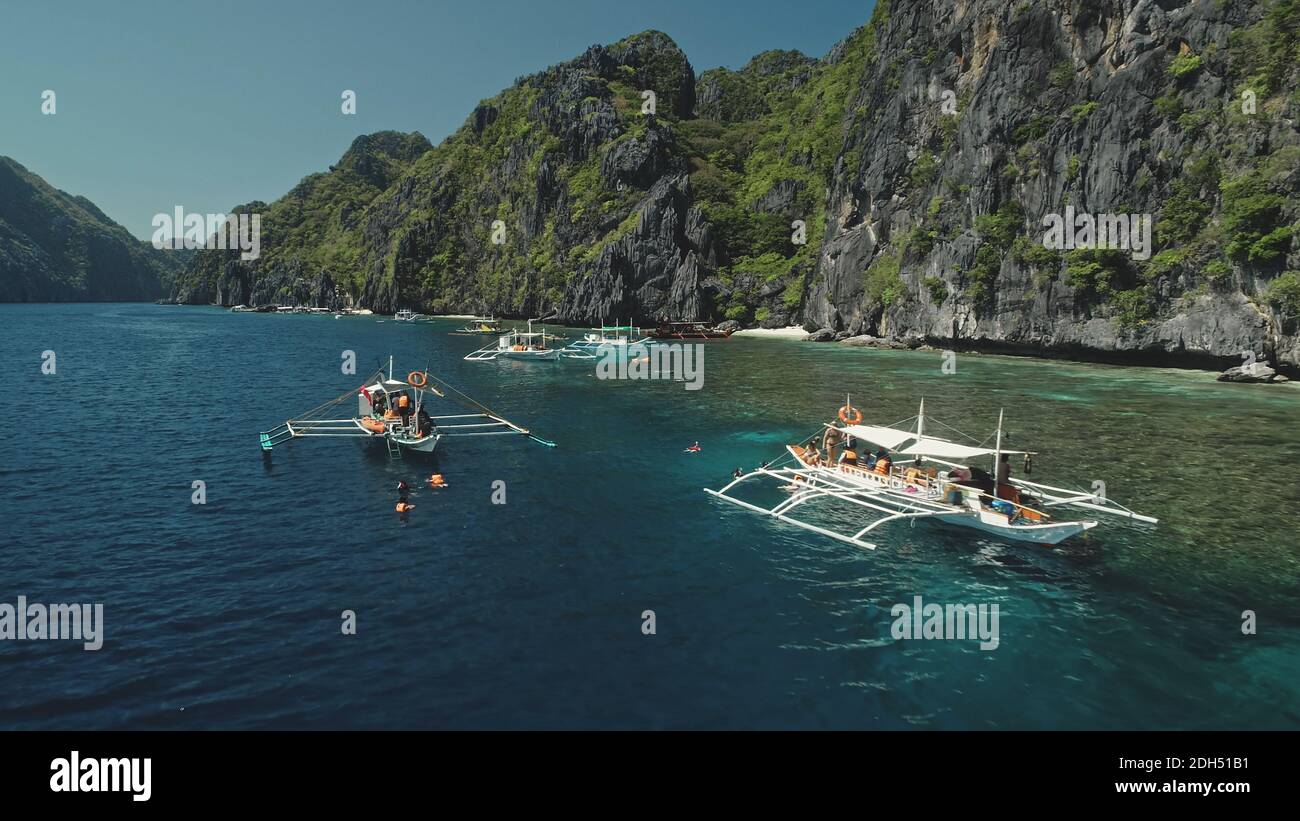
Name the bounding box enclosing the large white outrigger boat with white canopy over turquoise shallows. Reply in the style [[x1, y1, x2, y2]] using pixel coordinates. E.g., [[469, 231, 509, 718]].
[[705, 400, 1157, 549]]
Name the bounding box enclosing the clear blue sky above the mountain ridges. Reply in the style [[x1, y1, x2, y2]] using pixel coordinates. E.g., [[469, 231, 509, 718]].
[[0, 0, 874, 239]]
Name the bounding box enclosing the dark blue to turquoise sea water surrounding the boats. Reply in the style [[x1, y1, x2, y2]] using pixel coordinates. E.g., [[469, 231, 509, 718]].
[[0, 305, 1300, 729]]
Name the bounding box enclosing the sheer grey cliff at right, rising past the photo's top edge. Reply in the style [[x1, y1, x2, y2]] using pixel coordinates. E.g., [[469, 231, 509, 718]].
[[805, 0, 1300, 365]]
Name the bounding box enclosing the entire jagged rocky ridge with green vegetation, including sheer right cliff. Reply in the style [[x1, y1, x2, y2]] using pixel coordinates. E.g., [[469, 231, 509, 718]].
[[167, 0, 1300, 369]]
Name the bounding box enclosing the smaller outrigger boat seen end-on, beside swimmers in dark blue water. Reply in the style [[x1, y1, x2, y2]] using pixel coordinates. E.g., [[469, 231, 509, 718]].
[[260, 357, 555, 456]]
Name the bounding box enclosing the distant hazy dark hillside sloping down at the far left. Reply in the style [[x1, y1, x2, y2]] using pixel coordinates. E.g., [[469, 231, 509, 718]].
[[0, 157, 181, 303]]
